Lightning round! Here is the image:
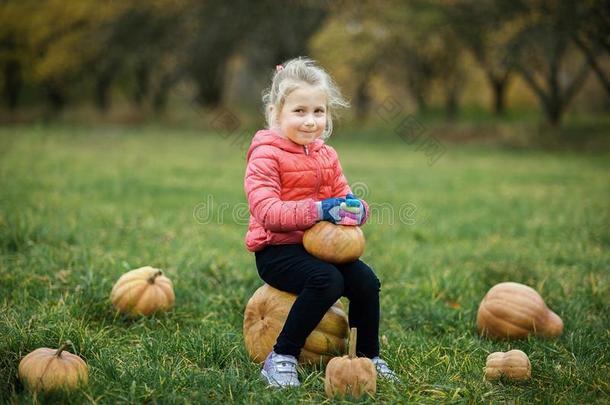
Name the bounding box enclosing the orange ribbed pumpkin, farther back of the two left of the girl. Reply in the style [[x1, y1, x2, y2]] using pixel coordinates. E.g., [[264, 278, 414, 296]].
[[110, 266, 175, 315]]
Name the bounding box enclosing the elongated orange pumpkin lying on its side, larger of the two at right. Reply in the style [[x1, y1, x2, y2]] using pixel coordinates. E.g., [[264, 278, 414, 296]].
[[477, 282, 563, 339]]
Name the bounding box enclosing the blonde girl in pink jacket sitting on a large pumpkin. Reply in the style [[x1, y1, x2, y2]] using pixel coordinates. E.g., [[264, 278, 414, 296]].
[[245, 58, 396, 387]]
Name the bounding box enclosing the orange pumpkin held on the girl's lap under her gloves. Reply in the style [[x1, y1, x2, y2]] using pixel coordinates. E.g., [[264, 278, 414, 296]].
[[303, 221, 365, 264]]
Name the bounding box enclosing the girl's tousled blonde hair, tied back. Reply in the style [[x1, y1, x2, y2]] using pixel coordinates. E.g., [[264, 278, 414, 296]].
[[263, 57, 349, 139]]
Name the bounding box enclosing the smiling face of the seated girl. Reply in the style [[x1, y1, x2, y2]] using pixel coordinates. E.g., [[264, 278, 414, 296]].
[[278, 84, 326, 145]]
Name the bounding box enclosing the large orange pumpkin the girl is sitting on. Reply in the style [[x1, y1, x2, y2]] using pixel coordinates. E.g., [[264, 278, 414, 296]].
[[243, 284, 348, 364]]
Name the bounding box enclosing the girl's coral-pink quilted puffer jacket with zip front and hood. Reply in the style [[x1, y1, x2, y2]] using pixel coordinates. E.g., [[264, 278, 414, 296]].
[[244, 130, 368, 252]]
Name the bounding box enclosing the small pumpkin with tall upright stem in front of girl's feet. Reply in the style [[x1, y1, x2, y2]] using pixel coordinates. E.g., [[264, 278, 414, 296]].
[[324, 328, 377, 399]]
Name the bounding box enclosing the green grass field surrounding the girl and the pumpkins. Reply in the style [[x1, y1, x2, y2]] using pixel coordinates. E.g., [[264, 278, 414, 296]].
[[0, 126, 610, 404]]
